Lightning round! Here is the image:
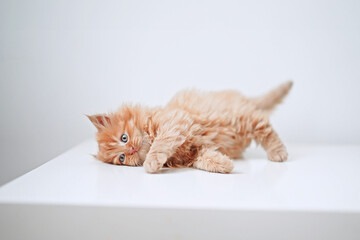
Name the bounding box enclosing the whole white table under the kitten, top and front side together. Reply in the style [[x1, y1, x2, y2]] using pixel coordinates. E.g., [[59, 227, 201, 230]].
[[0, 140, 360, 240]]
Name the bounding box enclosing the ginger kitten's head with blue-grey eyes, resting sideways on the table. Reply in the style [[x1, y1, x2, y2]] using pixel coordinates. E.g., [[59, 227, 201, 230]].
[[88, 105, 151, 166]]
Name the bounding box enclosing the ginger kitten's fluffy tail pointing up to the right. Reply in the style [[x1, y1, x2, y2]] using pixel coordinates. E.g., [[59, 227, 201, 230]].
[[252, 81, 293, 111]]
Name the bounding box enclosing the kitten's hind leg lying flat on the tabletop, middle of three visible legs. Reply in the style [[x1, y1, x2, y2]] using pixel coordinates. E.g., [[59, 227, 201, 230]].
[[192, 148, 234, 173]]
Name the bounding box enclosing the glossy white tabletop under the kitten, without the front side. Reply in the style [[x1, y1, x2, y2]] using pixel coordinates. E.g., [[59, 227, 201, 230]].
[[0, 140, 360, 214]]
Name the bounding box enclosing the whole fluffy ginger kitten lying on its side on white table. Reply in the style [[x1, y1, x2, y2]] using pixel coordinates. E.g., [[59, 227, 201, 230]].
[[88, 82, 292, 173]]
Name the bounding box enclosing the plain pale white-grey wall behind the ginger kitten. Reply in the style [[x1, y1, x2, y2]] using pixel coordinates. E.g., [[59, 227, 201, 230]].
[[0, 0, 360, 184]]
